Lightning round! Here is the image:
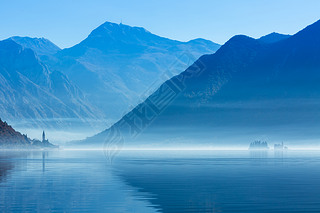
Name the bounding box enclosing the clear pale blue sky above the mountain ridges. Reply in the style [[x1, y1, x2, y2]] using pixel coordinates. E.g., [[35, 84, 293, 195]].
[[0, 0, 320, 48]]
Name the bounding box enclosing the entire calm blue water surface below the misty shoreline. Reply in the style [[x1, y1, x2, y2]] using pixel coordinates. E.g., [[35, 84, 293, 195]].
[[0, 151, 320, 213]]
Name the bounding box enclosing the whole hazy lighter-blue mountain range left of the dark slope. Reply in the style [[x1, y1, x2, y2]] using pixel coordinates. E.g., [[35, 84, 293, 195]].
[[0, 22, 220, 133]]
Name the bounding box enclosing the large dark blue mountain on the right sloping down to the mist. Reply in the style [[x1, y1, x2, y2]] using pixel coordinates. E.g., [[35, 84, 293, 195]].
[[74, 21, 320, 148]]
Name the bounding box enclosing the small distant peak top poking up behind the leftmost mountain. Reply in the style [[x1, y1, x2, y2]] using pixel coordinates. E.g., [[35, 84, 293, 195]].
[[9, 36, 61, 56]]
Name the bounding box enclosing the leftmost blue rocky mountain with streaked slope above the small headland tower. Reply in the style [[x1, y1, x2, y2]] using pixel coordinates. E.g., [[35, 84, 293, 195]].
[[0, 39, 100, 128]]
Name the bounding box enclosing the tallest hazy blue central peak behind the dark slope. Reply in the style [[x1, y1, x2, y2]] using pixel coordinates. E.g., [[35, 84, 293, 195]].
[[43, 22, 220, 121]]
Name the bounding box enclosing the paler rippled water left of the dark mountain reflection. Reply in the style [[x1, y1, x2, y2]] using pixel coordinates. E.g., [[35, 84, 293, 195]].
[[0, 151, 156, 213]]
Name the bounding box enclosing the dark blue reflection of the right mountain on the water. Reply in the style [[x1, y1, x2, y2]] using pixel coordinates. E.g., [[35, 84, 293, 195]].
[[117, 151, 320, 213]]
